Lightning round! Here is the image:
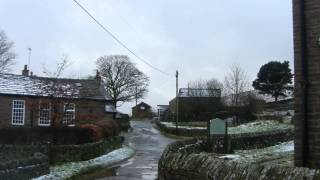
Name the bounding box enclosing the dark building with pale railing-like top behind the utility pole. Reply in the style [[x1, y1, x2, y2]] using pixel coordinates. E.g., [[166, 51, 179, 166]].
[[169, 88, 222, 121]]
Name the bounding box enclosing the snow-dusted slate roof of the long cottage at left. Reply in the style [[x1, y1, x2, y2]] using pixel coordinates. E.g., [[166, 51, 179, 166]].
[[0, 73, 110, 100]]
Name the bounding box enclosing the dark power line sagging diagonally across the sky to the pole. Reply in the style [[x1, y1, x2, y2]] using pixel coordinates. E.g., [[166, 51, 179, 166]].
[[73, 0, 172, 76]]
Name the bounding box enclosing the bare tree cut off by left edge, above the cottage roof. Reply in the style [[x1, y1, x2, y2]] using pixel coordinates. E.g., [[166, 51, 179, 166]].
[[0, 31, 16, 73]]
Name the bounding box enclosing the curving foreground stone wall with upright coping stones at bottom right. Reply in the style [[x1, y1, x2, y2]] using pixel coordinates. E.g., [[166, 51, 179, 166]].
[[158, 140, 320, 180]]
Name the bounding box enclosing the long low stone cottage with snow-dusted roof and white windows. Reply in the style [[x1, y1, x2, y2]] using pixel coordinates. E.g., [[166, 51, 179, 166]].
[[0, 66, 112, 128]]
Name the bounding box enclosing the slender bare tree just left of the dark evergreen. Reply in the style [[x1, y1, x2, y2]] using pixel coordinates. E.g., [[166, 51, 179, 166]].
[[225, 65, 250, 106]]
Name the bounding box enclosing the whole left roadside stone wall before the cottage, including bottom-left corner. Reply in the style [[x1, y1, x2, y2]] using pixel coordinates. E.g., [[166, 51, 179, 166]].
[[0, 136, 124, 180]]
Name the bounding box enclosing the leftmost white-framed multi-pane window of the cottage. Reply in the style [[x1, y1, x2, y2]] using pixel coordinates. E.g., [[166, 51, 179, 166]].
[[11, 100, 25, 125]]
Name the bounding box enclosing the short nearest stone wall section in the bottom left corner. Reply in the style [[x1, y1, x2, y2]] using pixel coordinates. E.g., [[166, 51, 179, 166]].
[[0, 153, 50, 180]]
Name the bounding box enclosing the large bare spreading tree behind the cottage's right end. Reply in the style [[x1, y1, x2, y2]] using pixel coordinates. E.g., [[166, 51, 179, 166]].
[[97, 55, 149, 107]]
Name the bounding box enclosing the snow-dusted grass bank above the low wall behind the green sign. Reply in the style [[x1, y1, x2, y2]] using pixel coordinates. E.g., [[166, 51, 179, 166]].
[[160, 120, 293, 134]]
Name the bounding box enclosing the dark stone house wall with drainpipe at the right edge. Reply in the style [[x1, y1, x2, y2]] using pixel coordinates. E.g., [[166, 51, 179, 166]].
[[293, 0, 320, 168]]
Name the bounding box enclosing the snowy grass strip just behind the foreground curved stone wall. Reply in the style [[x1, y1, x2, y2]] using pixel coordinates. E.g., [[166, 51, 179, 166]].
[[219, 141, 294, 162]]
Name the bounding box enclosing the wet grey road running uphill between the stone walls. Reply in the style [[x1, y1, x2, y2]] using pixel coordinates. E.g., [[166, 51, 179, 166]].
[[81, 120, 175, 180]]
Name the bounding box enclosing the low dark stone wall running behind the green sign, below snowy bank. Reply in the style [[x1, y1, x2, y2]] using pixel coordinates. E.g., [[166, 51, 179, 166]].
[[156, 121, 294, 150]]
